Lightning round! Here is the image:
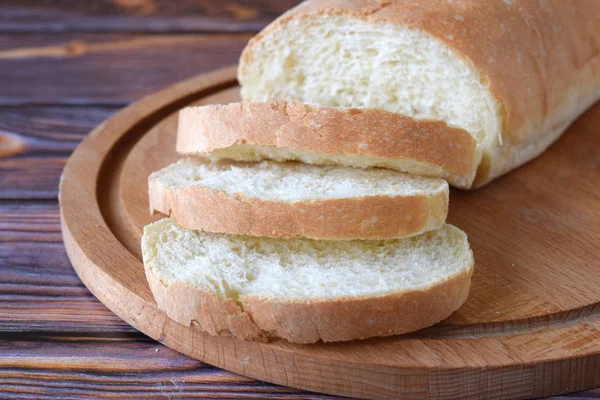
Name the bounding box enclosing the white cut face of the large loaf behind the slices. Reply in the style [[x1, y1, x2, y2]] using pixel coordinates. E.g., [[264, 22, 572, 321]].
[[239, 15, 501, 147]]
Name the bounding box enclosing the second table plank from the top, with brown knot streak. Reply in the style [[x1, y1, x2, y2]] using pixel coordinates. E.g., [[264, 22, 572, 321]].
[[0, 34, 250, 106]]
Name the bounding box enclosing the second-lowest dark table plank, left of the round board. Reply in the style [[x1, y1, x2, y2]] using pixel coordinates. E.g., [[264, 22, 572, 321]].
[[0, 201, 135, 332]]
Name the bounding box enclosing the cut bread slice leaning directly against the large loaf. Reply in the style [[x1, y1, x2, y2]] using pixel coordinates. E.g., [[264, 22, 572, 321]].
[[177, 101, 481, 187]]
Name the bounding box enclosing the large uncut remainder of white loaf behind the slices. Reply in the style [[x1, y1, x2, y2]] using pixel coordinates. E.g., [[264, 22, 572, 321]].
[[238, 0, 600, 187]]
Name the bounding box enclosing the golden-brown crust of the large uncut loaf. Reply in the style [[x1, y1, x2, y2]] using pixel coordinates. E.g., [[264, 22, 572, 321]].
[[239, 0, 600, 186]]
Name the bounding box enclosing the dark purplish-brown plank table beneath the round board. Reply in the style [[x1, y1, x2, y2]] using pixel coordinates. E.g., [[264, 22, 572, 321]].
[[0, 0, 600, 399]]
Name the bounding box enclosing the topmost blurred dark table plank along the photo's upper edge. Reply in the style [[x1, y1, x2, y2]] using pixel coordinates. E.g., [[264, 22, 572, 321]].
[[0, 0, 300, 32]]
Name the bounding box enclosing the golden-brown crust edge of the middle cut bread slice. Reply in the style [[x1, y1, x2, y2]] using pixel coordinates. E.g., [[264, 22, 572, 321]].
[[148, 163, 448, 240]]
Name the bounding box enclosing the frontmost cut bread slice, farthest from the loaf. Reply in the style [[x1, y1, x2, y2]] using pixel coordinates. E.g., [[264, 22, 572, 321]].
[[142, 219, 473, 343]]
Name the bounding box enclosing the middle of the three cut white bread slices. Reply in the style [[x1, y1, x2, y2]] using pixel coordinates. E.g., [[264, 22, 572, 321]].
[[148, 159, 448, 239]]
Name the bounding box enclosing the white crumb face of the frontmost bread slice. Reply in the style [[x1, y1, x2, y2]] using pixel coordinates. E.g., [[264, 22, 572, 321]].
[[142, 218, 473, 305]]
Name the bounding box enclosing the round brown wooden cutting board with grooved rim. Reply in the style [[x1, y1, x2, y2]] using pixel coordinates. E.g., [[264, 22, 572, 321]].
[[60, 68, 600, 399]]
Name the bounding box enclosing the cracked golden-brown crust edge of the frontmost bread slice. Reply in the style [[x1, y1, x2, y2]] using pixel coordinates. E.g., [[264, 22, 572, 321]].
[[146, 250, 473, 343]]
